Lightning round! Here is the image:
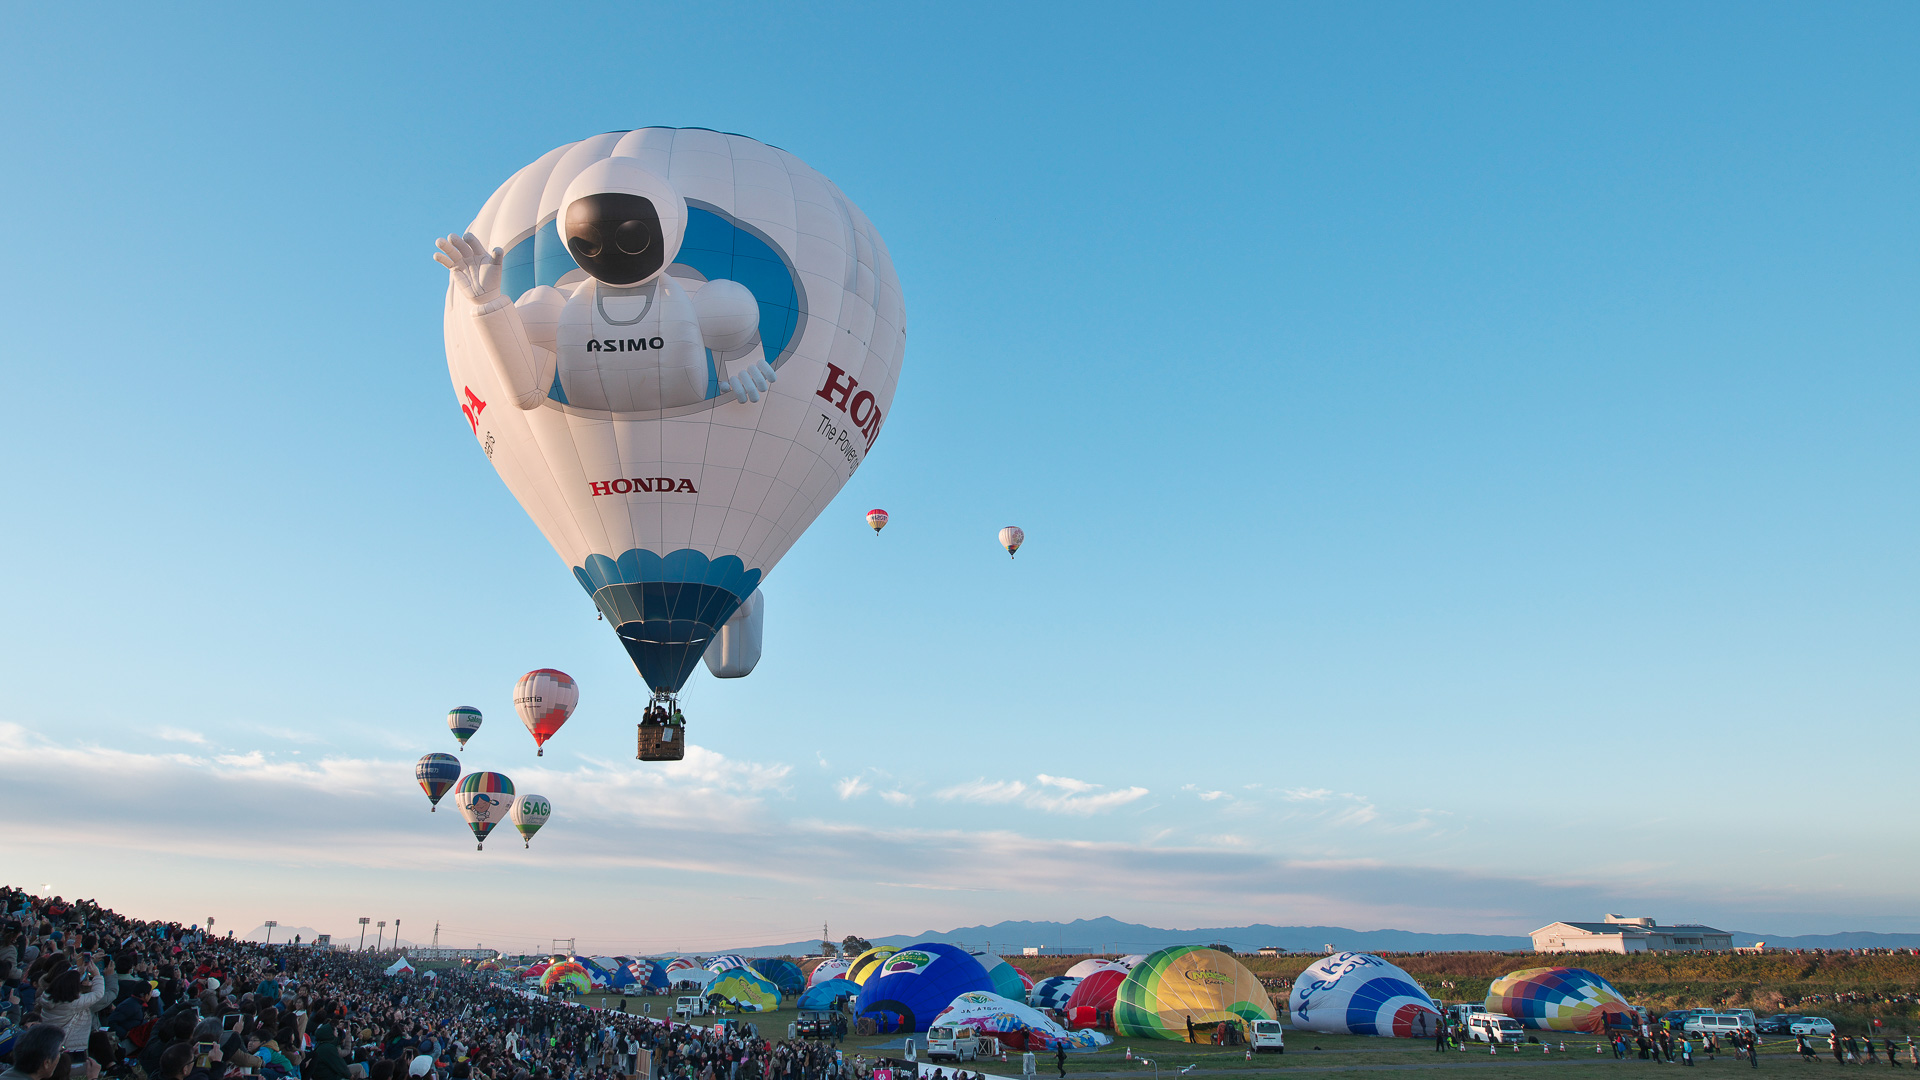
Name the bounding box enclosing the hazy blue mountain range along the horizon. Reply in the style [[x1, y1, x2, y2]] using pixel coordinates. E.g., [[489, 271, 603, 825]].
[[730, 917, 1920, 957]]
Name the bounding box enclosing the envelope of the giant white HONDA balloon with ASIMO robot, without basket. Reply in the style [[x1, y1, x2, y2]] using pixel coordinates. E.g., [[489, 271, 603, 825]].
[[436, 127, 906, 745]]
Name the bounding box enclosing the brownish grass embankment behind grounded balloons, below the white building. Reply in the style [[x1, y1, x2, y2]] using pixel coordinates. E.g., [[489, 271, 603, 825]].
[[1010, 953, 1920, 1036]]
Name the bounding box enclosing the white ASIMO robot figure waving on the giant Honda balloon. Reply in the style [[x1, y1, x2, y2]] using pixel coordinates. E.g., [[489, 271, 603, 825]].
[[434, 158, 774, 413]]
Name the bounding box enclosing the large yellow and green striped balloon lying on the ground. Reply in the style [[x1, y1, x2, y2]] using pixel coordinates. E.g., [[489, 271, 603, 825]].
[[1114, 945, 1279, 1042]]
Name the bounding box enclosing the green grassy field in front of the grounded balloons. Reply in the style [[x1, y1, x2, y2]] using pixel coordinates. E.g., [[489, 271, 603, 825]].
[[564, 995, 1885, 1080]]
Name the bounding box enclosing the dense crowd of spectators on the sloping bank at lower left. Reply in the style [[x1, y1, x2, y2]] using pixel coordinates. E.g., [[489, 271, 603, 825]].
[[0, 888, 906, 1080]]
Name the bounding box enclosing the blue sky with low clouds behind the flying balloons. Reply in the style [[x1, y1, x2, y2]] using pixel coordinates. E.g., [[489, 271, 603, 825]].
[[0, 4, 1920, 949]]
